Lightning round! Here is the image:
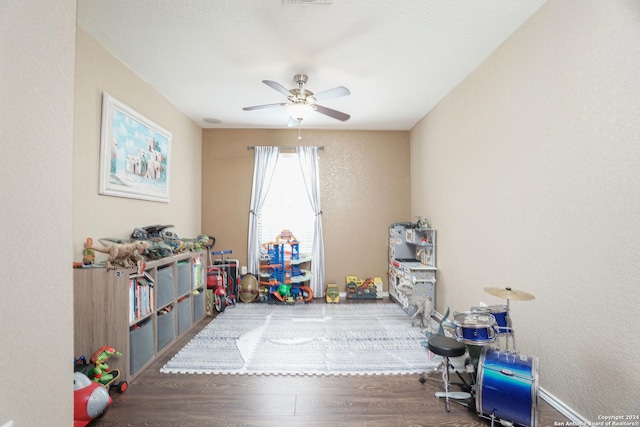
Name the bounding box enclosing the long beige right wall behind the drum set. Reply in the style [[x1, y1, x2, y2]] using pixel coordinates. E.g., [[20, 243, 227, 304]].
[[411, 0, 640, 421]]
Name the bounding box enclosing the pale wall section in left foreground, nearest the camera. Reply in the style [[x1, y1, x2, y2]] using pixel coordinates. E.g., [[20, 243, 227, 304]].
[[0, 0, 76, 427]]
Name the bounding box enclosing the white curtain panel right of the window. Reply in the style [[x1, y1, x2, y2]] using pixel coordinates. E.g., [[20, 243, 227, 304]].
[[296, 147, 324, 298]]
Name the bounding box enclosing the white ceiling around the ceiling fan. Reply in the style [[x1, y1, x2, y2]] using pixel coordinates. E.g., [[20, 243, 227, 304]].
[[78, 0, 545, 130]]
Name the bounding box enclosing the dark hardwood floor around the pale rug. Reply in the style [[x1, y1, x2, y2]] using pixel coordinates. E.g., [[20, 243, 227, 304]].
[[90, 300, 567, 427]]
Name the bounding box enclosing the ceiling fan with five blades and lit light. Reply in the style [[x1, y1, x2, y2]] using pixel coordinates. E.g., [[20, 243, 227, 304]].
[[243, 74, 351, 126]]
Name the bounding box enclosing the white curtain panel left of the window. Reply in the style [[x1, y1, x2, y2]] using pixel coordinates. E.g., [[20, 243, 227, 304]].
[[247, 147, 280, 276]]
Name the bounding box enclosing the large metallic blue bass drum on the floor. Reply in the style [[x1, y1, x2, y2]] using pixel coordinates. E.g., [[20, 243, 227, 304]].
[[476, 347, 538, 427]]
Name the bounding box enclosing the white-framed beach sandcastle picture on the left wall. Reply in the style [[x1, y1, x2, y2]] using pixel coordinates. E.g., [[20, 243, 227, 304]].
[[100, 92, 171, 203]]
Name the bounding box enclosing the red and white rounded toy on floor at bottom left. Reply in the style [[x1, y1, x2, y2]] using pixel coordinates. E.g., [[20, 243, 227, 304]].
[[73, 372, 112, 427]]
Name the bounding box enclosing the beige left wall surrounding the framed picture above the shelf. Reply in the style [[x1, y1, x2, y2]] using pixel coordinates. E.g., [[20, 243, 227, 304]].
[[73, 29, 202, 261]]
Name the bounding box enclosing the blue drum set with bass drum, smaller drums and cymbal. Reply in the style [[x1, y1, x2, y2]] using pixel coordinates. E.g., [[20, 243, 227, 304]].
[[436, 287, 538, 427]]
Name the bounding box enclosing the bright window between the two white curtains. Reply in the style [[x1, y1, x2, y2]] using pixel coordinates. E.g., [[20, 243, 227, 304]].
[[258, 153, 315, 254]]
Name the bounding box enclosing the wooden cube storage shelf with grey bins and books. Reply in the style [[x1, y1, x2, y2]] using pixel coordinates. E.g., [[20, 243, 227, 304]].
[[73, 252, 206, 381]]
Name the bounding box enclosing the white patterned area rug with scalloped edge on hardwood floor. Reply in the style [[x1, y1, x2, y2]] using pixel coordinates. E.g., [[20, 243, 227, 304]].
[[161, 303, 440, 375]]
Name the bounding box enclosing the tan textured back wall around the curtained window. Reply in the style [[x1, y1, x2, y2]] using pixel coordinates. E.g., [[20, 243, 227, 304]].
[[202, 129, 410, 291]]
